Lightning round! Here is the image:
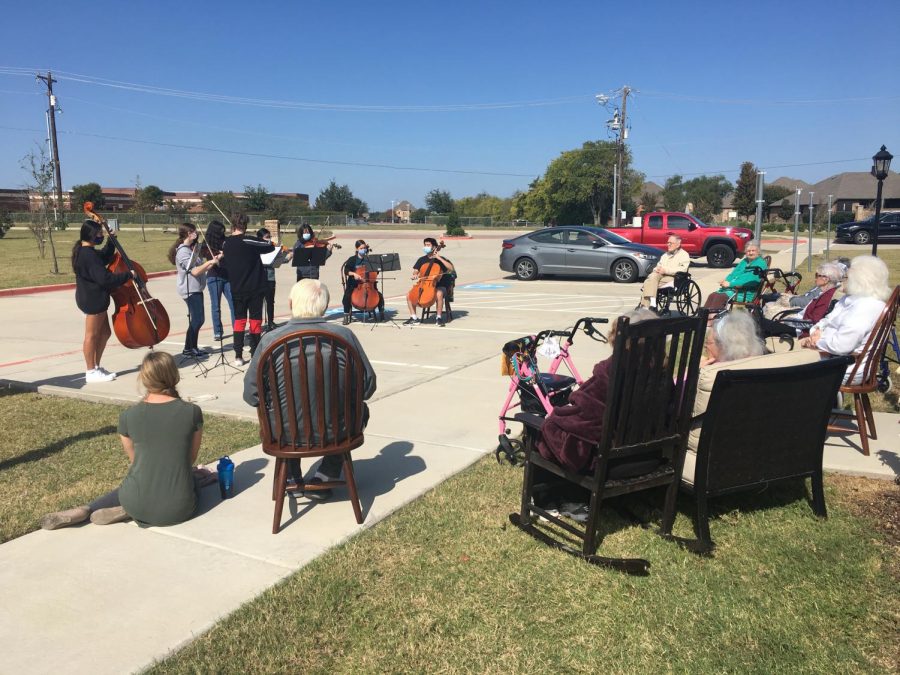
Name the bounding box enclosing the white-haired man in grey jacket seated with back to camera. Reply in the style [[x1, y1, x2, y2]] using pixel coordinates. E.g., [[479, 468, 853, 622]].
[[244, 279, 376, 501]]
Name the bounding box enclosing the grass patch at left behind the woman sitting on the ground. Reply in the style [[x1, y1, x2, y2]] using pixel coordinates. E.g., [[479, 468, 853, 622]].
[[0, 389, 259, 542]]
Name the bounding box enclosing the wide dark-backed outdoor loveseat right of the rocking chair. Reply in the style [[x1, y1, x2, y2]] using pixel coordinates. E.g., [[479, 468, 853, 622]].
[[682, 356, 853, 551]]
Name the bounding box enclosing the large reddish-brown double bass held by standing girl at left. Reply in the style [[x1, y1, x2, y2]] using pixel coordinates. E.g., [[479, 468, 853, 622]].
[[84, 202, 169, 349]]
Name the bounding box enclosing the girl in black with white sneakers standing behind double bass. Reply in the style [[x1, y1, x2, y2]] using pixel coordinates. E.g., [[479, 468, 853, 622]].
[[72, 220, 134, 383]]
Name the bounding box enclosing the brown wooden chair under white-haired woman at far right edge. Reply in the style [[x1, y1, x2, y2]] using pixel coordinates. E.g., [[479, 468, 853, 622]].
[[828, 286, 900, 456]]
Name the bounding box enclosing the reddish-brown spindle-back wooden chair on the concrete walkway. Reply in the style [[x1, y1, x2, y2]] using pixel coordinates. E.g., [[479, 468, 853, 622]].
[[256, 330, 365, 534]]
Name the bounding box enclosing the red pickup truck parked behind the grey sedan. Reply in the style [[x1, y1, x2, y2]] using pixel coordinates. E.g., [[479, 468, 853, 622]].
[[609, 211, 753, 267]]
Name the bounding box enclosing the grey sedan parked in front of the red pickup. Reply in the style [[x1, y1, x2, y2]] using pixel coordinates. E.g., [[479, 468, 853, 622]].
[[500, 225, 662, 283]]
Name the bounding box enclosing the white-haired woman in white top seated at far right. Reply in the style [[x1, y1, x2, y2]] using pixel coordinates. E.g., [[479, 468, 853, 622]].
[[800, 255, 891, 384]]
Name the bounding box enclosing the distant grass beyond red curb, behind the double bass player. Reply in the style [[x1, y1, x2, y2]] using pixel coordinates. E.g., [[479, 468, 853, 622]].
[[0, 227, 176, 289]]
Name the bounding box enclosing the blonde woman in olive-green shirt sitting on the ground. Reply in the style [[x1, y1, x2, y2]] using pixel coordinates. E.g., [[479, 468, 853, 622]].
[[41, 352, 214, 530]]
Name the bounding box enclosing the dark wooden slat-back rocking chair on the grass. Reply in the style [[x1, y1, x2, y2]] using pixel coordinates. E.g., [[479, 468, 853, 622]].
[[510, 310, 707, 574]]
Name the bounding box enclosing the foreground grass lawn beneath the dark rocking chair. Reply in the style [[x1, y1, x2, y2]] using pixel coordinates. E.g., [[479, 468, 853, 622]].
[[150, 458, 900, 673]]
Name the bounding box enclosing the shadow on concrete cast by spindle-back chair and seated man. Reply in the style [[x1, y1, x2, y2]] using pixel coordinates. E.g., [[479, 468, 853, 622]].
[[282, 441, 426, 528]]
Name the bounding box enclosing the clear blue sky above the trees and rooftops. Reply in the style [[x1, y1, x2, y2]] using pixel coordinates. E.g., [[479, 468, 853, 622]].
[[0, 0, 900, 210]]
